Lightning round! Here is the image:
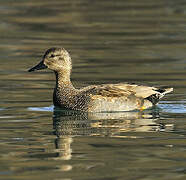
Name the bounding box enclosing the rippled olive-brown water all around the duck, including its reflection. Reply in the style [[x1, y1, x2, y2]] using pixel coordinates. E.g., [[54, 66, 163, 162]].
[[0, 0, 186, 180]]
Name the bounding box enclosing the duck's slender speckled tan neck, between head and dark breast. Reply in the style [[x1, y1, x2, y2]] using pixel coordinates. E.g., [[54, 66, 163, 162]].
[[55, 71, 74, 89]]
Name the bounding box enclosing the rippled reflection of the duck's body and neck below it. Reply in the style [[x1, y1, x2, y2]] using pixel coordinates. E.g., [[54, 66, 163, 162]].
[[53, 108, 173, 160]]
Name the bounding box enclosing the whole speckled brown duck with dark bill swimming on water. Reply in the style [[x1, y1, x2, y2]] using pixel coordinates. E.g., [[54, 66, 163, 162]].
[[28, 47, 173, 112]]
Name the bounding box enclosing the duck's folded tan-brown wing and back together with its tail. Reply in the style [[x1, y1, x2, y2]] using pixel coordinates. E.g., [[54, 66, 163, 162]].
[[84, 83, 173, 105]]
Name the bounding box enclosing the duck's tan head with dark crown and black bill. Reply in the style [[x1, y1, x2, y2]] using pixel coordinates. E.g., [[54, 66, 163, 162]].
[[28, 48, 72, 72]]
